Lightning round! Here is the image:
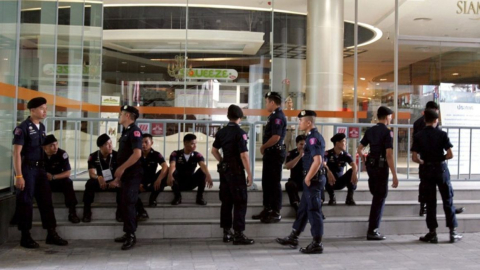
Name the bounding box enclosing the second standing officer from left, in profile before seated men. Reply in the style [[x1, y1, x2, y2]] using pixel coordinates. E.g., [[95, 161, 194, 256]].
[[110, 105, 143, 250]]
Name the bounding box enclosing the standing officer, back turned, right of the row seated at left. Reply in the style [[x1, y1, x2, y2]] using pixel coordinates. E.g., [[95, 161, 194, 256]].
[[212, 105, 255, 245]]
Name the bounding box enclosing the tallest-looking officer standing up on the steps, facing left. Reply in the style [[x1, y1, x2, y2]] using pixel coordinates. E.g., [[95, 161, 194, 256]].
[[252, 92, 287, 223]]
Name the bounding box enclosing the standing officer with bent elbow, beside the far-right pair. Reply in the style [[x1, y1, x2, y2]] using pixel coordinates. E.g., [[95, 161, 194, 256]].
[[357, 106, 398, 240]]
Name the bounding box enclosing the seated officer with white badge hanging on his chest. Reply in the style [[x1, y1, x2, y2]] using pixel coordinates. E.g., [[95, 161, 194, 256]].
[[82, 134, 123, 222]]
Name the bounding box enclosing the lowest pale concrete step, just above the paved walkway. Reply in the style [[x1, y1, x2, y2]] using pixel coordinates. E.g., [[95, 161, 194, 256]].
[[9, 214, 480, 241]]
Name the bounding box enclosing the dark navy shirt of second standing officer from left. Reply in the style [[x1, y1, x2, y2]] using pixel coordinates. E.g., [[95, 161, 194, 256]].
[[118, 123, 142, 169]]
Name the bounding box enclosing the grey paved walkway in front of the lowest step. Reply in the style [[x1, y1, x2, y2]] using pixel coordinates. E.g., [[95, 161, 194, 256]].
[[0, 233, 480, 270]]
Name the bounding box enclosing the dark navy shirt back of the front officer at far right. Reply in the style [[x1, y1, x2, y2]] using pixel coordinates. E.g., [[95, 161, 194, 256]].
[[411, 126, 453, 162]]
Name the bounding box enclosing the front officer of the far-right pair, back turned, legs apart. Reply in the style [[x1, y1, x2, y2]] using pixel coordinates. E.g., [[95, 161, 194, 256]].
[[411, 109, 462, 243]]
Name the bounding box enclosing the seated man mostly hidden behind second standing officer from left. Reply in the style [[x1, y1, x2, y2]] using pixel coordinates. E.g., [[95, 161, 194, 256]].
[[137, 133, 168, 221]]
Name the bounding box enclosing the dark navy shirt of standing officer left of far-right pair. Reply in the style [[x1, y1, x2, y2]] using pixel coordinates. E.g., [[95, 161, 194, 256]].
[[360, 123, 393, 158]]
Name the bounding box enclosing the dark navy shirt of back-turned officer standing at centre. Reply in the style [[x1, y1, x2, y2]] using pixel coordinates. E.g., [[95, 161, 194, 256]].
[[213, 122, 248, 169]]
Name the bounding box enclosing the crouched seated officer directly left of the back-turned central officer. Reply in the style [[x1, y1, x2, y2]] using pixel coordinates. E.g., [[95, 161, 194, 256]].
[[167, 134, 213, 205]]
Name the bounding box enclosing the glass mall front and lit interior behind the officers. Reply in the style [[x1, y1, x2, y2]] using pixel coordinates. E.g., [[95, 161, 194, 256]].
[[0, 0, 480, 247]]
